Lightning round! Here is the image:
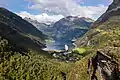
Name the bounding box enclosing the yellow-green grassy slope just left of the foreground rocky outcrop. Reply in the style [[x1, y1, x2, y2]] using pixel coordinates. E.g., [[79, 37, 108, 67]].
[[68, 53, 93, 80]]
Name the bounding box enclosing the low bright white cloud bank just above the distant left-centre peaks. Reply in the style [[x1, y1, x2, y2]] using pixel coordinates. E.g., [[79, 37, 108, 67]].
[[16, 11, 64, 24]]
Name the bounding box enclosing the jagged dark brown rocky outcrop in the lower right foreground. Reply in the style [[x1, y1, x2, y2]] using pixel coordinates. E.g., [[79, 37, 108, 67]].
[[88, 50, 120, 80]]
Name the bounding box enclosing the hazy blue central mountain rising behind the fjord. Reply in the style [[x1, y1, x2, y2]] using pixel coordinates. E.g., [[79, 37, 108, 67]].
[[52, 16, 94, 43]]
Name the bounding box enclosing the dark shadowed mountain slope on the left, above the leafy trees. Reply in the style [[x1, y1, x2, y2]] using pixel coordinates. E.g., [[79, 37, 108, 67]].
[[0, 7, 46, 51]]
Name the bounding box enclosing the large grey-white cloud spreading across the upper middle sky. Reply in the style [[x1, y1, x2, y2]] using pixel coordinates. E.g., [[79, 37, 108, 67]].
[[26, 0, 107, 19]]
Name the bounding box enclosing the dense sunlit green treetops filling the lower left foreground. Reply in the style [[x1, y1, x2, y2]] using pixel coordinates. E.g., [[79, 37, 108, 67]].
[[0, 39, 70, 80]]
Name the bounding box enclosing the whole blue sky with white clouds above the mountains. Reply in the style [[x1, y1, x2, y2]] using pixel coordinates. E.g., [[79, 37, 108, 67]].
[[0, 0, 112, 22]]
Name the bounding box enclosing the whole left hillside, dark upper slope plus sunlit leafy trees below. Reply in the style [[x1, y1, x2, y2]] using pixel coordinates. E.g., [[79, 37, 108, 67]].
[[0, 8, 72, 80]]
